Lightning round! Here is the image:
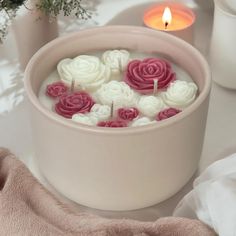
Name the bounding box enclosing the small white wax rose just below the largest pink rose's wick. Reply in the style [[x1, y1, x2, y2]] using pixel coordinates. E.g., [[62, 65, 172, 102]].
[[137, 95, 165, 117]]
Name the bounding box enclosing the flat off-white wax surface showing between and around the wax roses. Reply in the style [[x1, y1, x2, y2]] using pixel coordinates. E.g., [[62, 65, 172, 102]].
[[38, 51, 193, 126]]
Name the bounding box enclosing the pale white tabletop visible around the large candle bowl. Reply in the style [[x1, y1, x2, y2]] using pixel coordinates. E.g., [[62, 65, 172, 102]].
[[0, 0, 236, 220]]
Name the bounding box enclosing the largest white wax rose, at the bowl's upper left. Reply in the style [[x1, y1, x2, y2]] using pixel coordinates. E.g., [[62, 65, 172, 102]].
[[57, 55, 111, 91]]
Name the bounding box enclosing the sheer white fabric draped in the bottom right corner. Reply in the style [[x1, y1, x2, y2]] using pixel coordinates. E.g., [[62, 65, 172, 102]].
[[173, 153, 236, 236]]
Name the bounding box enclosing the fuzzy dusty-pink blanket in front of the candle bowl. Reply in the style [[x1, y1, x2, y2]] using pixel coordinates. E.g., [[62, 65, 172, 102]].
[[0, 149, 215, 236]]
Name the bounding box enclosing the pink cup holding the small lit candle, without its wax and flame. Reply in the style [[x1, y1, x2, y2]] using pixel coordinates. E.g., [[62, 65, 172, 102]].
[[143, 1, 196, 44]]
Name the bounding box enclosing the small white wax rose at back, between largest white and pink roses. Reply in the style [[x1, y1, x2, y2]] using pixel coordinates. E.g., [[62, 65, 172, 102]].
[[102, 50, 130, 75]]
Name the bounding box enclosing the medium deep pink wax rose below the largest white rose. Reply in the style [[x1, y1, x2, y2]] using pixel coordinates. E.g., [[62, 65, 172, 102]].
[[55, 92, 95, 118]]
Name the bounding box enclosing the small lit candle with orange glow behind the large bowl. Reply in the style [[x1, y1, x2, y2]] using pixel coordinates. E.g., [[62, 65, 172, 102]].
[[143, 2, 195, 44]]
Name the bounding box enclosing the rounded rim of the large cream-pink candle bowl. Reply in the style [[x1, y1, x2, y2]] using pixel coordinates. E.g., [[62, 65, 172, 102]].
[[25, 25, 211, 135]]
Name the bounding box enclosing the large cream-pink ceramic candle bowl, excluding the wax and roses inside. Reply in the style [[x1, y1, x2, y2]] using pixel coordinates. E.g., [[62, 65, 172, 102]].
[[25, 26, 211, 210]]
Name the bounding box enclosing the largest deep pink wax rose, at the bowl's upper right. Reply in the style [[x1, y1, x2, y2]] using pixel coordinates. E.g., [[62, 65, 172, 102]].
[[125, 58, 176, 94]]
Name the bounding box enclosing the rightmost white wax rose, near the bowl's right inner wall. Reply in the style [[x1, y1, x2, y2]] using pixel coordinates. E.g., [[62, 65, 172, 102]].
[[162, 80, 198, 109]]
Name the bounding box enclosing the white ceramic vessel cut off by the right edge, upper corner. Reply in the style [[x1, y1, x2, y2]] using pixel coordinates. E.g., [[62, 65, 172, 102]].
[[210, 0, 236, 89]]
